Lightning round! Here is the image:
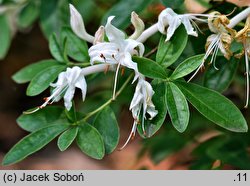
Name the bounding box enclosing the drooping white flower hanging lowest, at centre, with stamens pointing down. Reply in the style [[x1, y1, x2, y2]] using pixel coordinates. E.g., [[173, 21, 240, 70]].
[[120, 76, 158, 149]]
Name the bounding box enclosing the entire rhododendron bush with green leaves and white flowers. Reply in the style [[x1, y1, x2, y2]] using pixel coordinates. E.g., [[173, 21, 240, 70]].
[[0, 0, 250, 169]]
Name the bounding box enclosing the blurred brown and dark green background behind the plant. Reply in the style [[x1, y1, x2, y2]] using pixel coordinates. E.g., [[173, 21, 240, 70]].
[[0, 0, 250, 169]]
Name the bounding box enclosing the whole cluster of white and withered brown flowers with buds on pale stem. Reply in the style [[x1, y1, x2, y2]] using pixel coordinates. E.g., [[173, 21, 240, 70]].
[[28, 5, 250, 149]]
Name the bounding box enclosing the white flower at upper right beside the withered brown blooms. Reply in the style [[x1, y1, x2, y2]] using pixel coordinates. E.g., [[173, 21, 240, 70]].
[[157, 8, 209, 41]]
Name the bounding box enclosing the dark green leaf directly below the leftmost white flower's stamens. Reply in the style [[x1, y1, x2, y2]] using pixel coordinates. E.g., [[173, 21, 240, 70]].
[[17, 106, 69, 132]]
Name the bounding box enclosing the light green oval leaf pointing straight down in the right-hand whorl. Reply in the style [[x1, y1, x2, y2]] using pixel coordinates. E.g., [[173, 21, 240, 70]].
[[166, 82, 190, 132]]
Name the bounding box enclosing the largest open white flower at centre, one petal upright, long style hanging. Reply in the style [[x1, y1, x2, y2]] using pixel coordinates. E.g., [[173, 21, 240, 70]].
[[89, 16, 144, 98]]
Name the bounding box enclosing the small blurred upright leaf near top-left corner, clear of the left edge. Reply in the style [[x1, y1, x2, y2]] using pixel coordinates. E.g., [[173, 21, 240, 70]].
[[17, 1, 40, 28]]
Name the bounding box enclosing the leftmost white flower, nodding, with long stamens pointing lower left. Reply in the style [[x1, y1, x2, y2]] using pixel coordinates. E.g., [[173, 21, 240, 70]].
[[29, 67, 87, 113]]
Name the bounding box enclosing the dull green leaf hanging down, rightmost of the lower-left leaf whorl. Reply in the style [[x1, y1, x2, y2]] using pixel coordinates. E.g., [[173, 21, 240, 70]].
[[93, 107, 120, 154]]
